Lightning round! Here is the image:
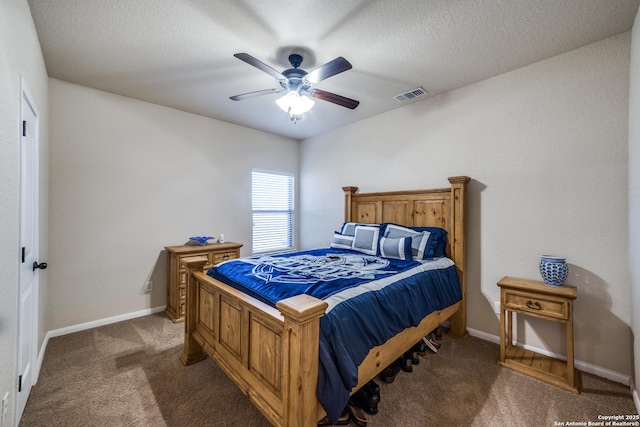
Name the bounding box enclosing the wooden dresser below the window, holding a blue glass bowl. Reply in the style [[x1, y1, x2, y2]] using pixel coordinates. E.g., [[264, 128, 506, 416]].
[[164, 242, 242, 322]]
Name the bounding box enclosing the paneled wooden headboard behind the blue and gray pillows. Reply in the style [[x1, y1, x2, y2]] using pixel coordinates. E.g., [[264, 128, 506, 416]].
[[342, 176, 470, 338]]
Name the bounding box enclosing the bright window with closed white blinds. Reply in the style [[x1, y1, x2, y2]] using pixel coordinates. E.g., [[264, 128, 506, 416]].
[[251, 171, 294, 253]]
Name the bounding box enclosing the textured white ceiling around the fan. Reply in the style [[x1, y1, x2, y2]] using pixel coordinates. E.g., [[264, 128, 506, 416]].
[[28, 0, 638, 139]]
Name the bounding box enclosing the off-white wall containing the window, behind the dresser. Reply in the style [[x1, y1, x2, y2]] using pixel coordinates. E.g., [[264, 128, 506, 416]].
[[49, 79, 298, 330]]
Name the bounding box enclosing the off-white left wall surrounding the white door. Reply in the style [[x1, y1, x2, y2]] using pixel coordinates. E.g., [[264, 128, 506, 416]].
[[0, 0, 48, 426]]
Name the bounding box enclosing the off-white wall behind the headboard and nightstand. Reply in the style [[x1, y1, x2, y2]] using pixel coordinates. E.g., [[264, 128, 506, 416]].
[[300, 33, 631, 376]]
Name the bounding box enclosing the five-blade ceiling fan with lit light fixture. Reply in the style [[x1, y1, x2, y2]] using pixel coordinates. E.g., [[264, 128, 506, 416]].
[[229, 53, 360, 120]]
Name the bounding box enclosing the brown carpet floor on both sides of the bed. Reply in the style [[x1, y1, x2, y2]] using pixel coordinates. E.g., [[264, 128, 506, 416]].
[[20, 314, 636, 427]]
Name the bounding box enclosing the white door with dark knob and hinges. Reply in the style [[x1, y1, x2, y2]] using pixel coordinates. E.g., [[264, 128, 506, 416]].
[[16, 81, 41, 425]]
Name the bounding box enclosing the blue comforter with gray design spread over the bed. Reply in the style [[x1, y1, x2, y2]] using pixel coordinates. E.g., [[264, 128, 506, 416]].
[[208, 248, 462, 422]]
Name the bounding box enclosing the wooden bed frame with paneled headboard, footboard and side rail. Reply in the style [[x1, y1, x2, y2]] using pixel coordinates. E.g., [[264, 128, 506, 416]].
[[181, 176, 469, 427]]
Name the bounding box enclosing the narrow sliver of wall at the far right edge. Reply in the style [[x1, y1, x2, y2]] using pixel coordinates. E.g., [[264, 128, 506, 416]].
[[629, 7, 640, 411]]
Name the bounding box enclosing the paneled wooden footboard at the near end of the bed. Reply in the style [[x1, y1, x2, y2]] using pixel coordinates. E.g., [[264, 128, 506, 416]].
[[181, 257, 327, 427]]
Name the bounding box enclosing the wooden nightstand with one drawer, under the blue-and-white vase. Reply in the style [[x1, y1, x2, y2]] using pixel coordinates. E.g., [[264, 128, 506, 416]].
[[498, 277, 580, 394]]
